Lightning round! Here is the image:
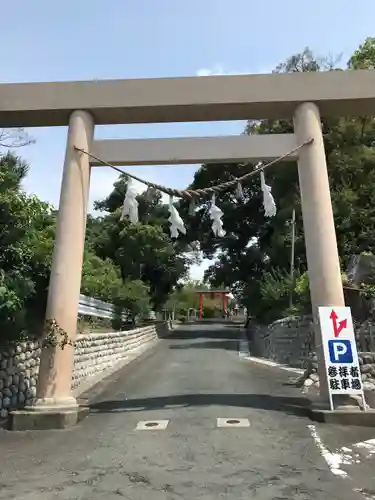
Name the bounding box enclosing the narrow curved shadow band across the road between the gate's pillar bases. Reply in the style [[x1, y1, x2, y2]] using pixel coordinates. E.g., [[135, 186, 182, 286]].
[[90, 394, 308, 416]]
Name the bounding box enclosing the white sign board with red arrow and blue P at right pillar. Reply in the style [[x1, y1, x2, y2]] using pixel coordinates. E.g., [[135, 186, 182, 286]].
[[319, 307, 363, 406]]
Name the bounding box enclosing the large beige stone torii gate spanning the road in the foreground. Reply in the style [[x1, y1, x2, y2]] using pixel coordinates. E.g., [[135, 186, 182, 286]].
[[0, 70, 375, 421]]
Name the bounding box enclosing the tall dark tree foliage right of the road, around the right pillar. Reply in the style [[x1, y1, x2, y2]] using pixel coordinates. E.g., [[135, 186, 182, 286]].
[[185, 38, 375, 319]]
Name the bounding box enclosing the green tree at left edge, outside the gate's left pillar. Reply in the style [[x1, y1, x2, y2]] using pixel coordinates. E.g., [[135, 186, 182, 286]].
[[0, 153, 54, 340]]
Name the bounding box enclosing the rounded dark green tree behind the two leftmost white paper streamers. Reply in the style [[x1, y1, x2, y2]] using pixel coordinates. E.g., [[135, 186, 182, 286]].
[[88, 176, 192, 309]]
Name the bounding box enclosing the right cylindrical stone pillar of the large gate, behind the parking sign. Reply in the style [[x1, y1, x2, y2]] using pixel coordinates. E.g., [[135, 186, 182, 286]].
[[294, 102, 345, 404]]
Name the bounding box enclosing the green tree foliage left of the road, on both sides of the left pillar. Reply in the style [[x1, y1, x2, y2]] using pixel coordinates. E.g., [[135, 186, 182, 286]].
[[0, 153, 191, 341]]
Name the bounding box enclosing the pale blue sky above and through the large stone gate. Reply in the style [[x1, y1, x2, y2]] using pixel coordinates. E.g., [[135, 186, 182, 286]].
[[1, 0, 375, 278]]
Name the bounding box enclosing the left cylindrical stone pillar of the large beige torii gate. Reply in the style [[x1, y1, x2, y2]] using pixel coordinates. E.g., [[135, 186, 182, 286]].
[[17, 111, 94, 426]]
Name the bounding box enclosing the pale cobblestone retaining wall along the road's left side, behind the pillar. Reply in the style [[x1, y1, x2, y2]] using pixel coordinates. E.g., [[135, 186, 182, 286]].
[[0, 325, 163, 418]]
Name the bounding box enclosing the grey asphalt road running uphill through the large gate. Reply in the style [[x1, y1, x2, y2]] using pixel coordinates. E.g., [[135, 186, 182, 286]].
[[0, 325, 375, 500]]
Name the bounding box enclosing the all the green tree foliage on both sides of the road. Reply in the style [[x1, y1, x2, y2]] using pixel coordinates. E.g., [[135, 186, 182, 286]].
[[0, 38, 375, 338]]
